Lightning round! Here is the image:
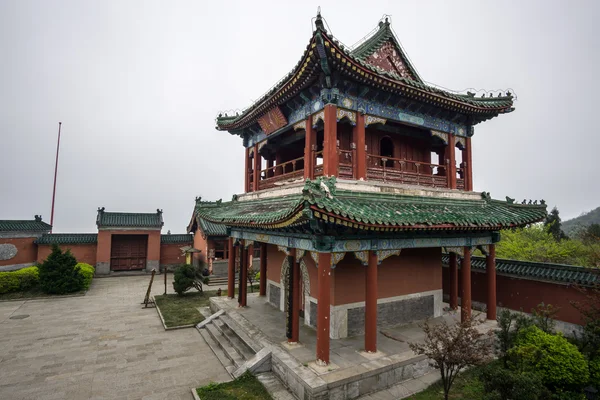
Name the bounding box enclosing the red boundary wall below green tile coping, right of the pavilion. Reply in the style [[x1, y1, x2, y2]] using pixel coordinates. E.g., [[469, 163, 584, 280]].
[[443, 268, 585, 324]]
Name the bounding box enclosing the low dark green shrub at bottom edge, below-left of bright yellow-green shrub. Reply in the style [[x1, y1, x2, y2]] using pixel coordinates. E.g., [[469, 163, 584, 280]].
[[479, 363, 546, 400]]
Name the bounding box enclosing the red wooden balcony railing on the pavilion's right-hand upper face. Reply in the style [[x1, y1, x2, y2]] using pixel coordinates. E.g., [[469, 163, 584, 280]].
[[367, 154, 448, 188]]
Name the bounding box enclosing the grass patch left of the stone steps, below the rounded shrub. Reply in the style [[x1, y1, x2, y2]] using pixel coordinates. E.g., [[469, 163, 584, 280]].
[[154, 291, 217, 328]]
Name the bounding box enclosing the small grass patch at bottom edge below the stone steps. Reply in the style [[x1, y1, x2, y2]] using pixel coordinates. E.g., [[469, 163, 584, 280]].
[[196, 372, 272, 400]]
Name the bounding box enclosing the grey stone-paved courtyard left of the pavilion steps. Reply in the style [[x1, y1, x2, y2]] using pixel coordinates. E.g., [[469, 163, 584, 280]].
[[0, 276, 229, 400]]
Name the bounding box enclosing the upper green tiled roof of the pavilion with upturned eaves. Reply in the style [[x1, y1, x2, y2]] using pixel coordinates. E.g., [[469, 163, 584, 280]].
[[217, 16, 513, 132]]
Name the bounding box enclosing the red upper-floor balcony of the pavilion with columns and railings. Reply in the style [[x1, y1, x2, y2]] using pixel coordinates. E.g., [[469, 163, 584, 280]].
[[246, 108, 472, 192]]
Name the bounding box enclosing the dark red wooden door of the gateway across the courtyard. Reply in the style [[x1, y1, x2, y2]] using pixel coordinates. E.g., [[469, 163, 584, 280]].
[[110, 235, 148, 271]]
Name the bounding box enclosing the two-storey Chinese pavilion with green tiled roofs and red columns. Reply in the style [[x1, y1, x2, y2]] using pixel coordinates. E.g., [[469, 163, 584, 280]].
[[195, 14, 546, 365]]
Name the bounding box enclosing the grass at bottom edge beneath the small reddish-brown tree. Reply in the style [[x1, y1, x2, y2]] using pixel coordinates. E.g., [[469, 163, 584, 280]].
[[408, 367, 485, 400]]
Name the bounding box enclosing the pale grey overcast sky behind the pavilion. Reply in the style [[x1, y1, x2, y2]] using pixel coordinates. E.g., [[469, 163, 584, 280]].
[[0, 0, 600, 233]]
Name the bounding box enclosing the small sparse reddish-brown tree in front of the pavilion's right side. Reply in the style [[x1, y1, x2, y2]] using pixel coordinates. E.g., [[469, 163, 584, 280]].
[[410, 320, 493, 400]]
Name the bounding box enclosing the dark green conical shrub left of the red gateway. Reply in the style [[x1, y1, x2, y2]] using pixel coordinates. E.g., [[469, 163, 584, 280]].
[[39, 245, 84, 294]]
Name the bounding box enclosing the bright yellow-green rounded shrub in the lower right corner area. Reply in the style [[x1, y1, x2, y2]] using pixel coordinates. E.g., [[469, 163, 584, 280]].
[[508, 326, 589, 389]]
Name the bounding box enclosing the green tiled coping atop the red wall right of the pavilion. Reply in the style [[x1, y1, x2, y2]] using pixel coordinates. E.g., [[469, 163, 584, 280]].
[[442, 255, 600, 285]]
